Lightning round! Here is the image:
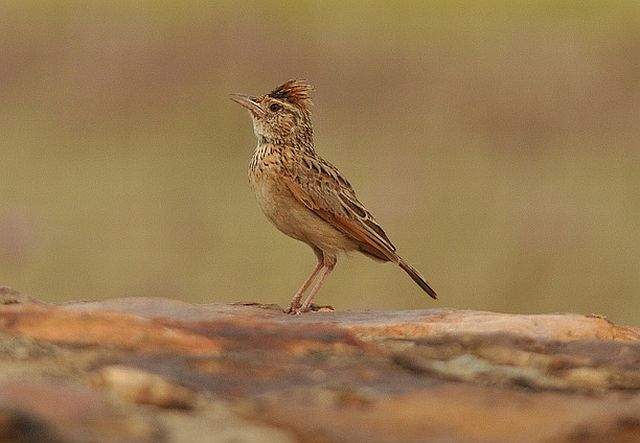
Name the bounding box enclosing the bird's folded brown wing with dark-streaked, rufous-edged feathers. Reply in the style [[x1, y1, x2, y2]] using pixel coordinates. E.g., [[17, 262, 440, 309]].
[[285, 155, 398, 262]]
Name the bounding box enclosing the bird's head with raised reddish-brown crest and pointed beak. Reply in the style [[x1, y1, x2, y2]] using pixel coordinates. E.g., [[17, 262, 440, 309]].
[[231, 80, 313, 143]]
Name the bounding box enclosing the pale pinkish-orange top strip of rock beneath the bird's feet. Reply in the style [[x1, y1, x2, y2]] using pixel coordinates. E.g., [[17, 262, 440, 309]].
[[64, 297, 640, 341]]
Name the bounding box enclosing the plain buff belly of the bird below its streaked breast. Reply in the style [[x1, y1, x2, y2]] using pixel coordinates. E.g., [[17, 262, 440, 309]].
[[252, 174, 357, 255]]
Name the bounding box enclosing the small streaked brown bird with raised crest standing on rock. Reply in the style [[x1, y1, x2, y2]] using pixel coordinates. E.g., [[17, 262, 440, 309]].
[[230, 79, 437, 315]]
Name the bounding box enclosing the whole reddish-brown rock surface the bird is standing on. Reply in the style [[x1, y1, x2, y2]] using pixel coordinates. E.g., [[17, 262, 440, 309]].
[[0, 288, 640, 443]]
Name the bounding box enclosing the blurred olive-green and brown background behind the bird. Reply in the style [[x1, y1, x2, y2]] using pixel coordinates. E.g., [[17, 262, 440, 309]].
[[0, 0, 640, 325]]
